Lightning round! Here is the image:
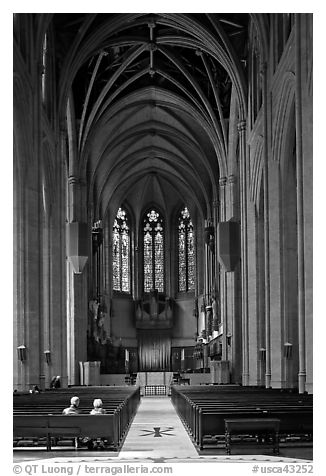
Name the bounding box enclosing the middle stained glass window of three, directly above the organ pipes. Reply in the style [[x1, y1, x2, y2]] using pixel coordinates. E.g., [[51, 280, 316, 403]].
[[143, 209, 164, 292]]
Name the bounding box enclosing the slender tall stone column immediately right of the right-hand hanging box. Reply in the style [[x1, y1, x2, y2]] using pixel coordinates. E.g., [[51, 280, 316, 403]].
[[238, 121, 249, 386]]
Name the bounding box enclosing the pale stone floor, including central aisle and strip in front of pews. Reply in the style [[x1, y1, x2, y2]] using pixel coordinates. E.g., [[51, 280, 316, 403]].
[[14, 397, 313, 463]]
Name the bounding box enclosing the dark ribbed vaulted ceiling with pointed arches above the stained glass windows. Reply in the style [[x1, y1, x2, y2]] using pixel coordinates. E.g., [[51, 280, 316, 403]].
[[53, 13, 248, 222]]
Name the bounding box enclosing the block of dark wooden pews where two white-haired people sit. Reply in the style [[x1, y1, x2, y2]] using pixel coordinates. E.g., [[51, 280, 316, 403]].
[[13, 386, 140, 450]]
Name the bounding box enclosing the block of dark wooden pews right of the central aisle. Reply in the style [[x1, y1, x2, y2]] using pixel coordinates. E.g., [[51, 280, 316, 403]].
[[171, 385, 313, 449]]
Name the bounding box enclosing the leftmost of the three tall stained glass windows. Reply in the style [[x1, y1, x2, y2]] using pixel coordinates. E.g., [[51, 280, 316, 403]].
[[112, 208, 130, 293]]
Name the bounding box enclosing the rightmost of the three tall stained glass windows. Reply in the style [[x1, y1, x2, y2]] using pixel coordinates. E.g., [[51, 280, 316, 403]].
[[178, 207, 195, 291]]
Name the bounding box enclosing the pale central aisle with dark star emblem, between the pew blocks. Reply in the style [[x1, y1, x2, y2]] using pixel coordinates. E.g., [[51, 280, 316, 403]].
[[120, 397, 198, 458]]
